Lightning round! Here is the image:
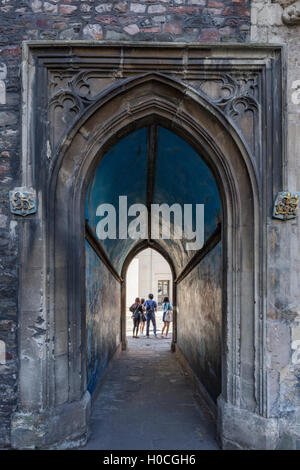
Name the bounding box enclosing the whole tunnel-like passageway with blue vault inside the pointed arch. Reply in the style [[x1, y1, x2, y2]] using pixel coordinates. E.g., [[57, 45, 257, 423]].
[[85, 124, 222, 449]]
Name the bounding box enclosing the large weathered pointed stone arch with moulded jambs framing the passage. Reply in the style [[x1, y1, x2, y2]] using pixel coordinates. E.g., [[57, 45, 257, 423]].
[[12, 43, 284, 448]]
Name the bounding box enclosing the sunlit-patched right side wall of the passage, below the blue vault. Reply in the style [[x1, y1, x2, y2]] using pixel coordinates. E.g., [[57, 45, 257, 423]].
[[177, 243, 222, 401]]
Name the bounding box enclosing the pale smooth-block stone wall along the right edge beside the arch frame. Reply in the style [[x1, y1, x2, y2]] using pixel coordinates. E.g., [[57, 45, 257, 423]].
[[251, 0, 300, 449]]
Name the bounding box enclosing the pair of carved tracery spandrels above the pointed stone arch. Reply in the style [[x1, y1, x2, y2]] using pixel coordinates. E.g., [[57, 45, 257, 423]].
[[48, 70, 260, 162]]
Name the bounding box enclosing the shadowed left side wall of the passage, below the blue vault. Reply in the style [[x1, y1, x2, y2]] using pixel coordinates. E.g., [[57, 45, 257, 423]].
[[85, 242, 121, 394]]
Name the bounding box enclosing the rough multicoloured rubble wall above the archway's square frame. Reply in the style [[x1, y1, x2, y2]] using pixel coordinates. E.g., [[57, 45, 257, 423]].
[[0, 0, 250, 44]]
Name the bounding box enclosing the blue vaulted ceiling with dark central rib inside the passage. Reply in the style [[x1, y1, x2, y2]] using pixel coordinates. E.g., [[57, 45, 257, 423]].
[[85, 125, 221, 273]]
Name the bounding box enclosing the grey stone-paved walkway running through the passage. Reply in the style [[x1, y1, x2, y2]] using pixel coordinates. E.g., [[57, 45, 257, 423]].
[[83, 314, 218, 450]]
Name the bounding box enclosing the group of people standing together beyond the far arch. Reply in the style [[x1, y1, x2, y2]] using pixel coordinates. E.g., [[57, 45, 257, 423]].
[[129, 294, 173, 338]]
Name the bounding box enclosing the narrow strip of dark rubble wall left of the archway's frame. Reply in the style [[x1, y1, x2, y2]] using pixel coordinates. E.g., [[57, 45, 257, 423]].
[[0, 45, 20, 447]]
